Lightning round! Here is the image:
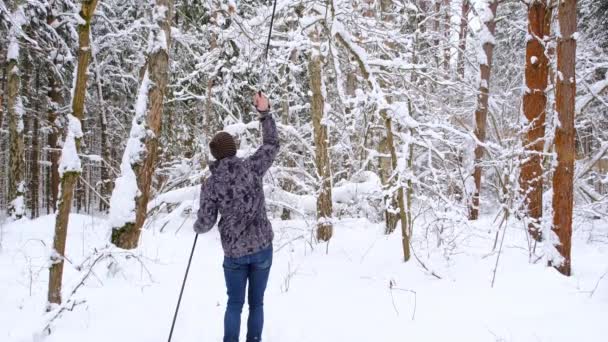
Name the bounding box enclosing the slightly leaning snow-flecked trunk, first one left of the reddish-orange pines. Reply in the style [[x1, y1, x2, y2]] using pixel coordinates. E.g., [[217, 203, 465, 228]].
[[469, 0, 498, 220]]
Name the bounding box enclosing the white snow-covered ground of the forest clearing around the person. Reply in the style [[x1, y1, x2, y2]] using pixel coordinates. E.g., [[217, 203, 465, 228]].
[[0, 215, 608, 342]]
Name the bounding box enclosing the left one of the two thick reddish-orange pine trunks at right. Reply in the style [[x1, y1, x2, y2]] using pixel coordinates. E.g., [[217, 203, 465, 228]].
[[519, 0, 548, 240]]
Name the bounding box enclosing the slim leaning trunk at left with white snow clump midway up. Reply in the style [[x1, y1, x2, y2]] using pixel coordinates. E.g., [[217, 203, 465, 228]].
[[48, 0, 97, 309]]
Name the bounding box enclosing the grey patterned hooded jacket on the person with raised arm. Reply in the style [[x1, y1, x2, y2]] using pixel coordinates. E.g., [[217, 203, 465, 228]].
[[194, 114, 279, 258]]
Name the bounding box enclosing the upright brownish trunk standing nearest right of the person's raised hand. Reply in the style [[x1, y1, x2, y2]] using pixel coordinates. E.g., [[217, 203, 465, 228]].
[[308, 53, 333, 241]]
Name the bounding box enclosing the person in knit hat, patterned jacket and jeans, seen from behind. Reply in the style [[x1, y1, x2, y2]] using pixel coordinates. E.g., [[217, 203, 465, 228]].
[[194, 93, 279, 342]]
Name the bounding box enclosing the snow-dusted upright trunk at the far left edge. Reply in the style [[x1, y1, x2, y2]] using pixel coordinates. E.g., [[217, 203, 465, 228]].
[[7, 1, 26, 219]]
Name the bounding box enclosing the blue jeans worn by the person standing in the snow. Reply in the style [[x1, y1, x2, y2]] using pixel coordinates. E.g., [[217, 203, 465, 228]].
[[224, 247, 272, 342]]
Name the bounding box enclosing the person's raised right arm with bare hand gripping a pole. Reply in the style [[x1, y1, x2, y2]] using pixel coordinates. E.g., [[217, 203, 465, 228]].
[[248, 94, 280, 176]]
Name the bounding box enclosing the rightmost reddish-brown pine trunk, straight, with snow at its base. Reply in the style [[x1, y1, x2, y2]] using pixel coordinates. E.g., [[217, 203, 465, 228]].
[[550, 0, 576, 276]]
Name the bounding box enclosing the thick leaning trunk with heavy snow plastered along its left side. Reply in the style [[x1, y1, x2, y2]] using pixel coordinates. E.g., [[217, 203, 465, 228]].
[[110, 0, 173, 249]]
